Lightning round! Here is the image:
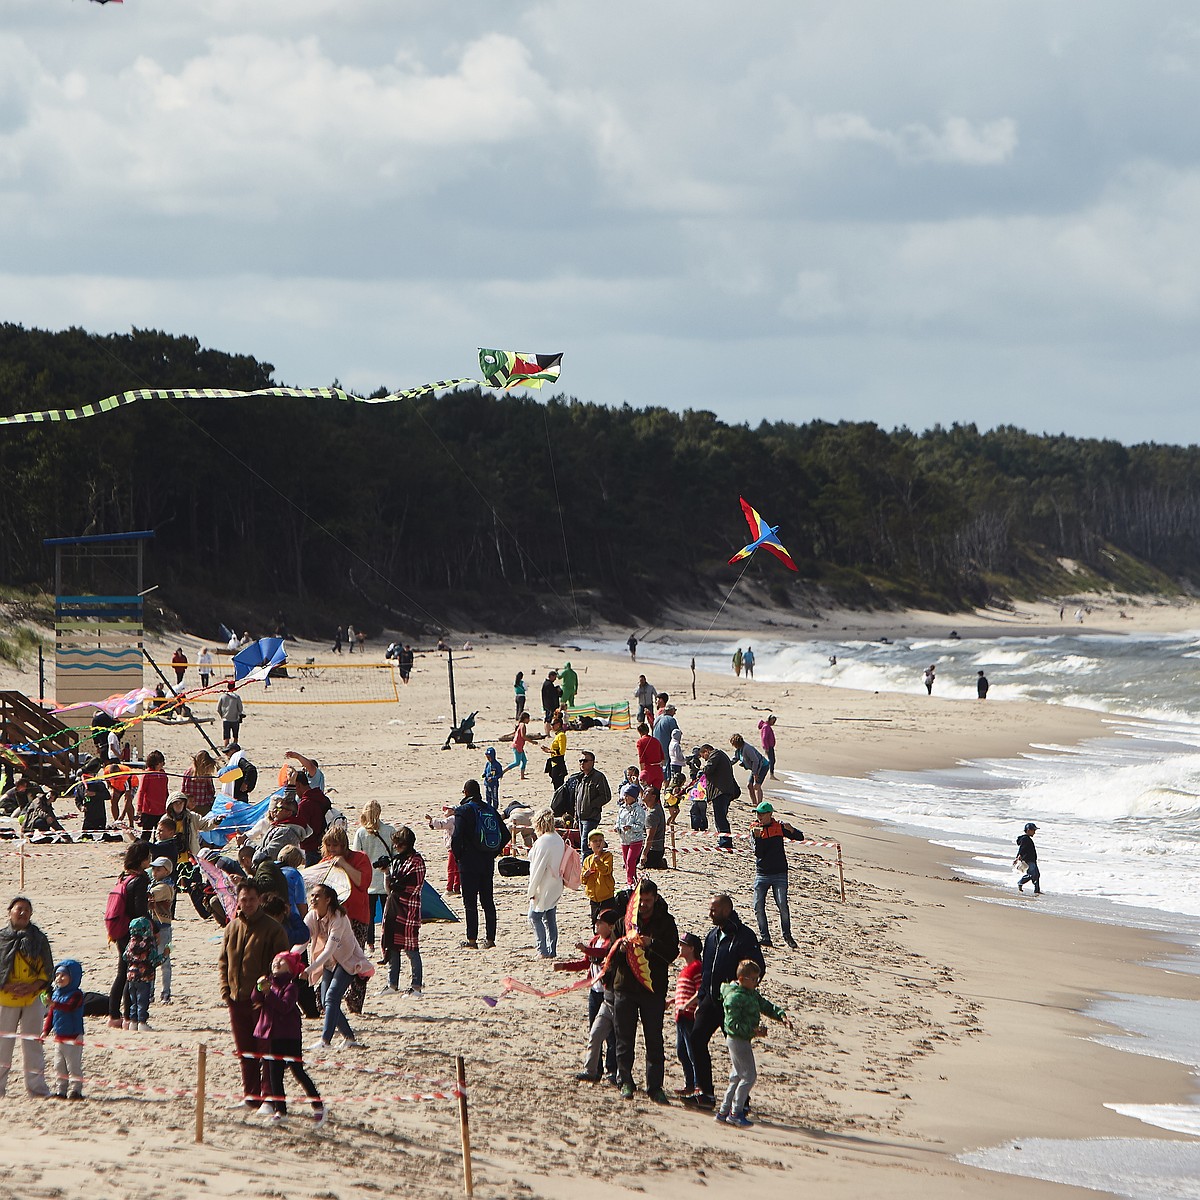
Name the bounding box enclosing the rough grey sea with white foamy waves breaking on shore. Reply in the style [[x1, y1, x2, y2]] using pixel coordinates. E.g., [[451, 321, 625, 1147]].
[[578, 625, 1200, 1200]]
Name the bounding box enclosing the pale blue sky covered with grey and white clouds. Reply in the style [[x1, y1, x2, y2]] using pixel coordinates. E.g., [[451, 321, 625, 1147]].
[[0, 0, 1200, 443]]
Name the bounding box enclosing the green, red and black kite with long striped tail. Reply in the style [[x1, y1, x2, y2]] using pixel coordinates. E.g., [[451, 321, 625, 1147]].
[[0, 350, 563, 425]]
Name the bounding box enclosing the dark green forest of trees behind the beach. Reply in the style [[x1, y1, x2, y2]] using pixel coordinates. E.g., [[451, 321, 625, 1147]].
[[0, 324, 1200, 634]]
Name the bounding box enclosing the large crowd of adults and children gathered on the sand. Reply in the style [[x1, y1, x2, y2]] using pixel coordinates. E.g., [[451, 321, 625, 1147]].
[[0, 652, 830, 1126]]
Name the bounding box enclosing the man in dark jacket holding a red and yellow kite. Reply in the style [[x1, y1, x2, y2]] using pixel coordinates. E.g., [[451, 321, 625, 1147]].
[[610, 878, 676, 1104]]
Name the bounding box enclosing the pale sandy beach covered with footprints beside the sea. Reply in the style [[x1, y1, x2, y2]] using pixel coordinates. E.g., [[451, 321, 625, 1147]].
[[0, 598, 1200, 1200]]
